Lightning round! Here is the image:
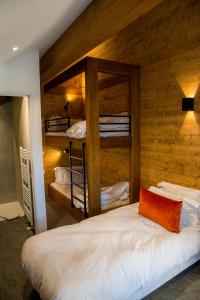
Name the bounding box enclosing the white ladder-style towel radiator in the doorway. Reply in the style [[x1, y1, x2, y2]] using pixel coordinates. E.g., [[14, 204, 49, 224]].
[[20, 147, 34, 226]]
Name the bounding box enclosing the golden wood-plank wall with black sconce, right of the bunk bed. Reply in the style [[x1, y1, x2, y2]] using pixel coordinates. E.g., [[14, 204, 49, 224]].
[[88, 0, 200, 188]]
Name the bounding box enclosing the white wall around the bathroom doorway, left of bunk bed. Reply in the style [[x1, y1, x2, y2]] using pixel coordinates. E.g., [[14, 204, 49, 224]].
[[0, 51, 47, 233]]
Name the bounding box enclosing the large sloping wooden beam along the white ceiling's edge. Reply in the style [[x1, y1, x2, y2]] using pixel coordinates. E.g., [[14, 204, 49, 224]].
[[40, 0, 162, 85]]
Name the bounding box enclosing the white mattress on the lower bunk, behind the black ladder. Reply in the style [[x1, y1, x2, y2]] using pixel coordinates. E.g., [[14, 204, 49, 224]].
[[50, 182, 129, 210]]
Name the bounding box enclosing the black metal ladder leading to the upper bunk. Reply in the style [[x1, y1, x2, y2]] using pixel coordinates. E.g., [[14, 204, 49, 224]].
[[69, 142, 88, 218]]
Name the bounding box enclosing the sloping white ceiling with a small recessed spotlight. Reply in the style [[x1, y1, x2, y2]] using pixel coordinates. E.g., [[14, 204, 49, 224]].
[[0, 0, 92, 63]]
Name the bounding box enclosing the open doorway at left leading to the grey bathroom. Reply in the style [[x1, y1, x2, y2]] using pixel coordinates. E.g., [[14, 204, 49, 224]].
[[0, 96, 33, 225]]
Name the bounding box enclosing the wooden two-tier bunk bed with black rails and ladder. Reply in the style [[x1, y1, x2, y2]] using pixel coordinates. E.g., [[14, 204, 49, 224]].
[[44, 57, 139, 221]]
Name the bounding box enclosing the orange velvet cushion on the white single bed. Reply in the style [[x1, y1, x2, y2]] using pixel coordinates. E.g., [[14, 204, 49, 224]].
[[139, 188, 182, 232]]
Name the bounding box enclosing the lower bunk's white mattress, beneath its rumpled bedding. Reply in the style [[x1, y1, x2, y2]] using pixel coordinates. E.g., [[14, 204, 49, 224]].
[[50, 182, 129, 211]]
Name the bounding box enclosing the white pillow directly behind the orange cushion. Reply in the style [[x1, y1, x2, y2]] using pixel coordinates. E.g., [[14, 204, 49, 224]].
[[149, 186, 199, 228]]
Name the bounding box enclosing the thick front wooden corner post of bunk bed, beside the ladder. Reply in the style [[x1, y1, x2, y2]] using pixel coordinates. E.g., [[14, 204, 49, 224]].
[[85, 58, 101, 216]]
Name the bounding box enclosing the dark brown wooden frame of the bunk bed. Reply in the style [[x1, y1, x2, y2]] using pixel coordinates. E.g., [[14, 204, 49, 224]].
[[44, 57, 140, 220]]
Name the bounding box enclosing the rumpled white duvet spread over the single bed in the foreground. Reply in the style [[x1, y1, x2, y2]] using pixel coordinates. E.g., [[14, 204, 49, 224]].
[[22, 205, 200, 300]]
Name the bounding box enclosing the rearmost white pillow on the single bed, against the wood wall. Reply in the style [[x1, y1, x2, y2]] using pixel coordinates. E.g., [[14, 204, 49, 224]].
[[157, 181, 200, 203]]
